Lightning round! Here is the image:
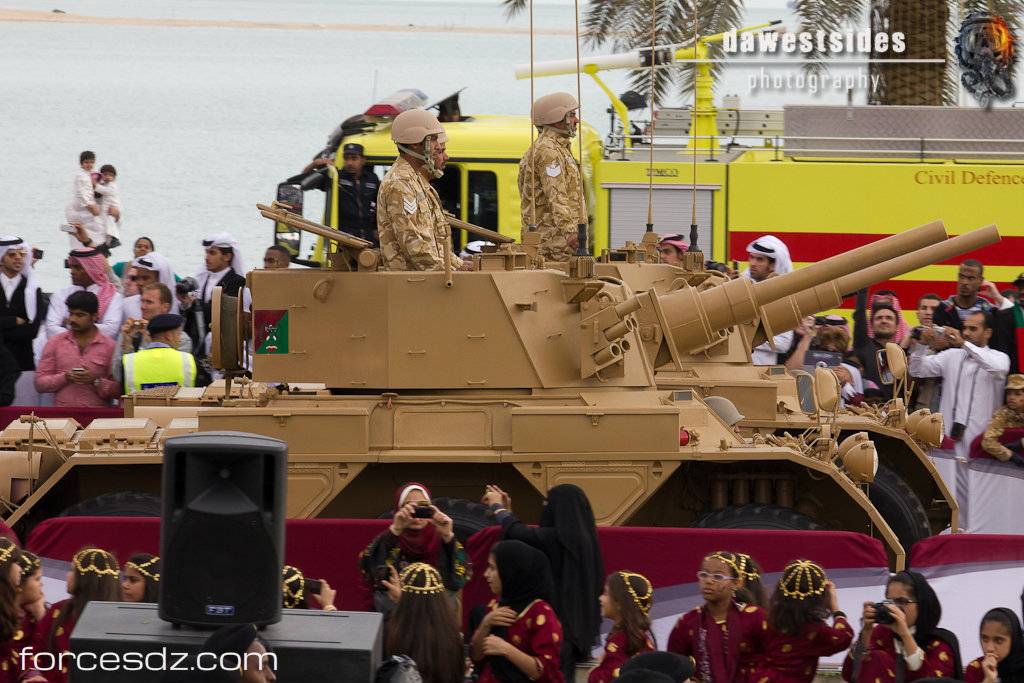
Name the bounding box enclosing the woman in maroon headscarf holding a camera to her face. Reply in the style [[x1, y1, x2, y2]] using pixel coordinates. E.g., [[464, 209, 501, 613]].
[[359, 482, 471, 613]]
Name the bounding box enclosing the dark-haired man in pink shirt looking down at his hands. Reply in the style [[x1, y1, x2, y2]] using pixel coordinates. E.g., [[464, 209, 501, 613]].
[[36, 291, 121, 408]]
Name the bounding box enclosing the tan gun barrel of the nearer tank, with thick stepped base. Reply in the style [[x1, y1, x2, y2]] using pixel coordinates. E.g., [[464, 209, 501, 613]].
[[641, 221, 946, 353]]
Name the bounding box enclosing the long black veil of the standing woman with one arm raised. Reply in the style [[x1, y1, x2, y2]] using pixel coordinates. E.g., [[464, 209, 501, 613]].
[[540, 483, 604, 659]]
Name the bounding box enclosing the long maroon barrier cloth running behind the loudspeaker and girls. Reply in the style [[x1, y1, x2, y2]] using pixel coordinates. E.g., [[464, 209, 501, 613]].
[[27, 517, 887, 609]]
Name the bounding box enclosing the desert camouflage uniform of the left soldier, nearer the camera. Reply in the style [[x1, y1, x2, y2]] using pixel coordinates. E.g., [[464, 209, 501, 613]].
[[377, 157, 462, 270]]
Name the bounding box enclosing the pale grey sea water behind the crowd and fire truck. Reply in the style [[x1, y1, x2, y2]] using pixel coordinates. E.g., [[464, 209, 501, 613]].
[[0, 0, 845, 290]]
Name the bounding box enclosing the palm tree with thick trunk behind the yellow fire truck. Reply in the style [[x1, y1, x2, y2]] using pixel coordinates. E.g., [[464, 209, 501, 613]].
[[502, 0, 1024, 104]]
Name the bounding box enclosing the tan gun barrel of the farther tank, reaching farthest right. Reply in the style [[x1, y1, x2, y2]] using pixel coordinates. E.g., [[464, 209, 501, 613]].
[[754, 225, 999, 344]]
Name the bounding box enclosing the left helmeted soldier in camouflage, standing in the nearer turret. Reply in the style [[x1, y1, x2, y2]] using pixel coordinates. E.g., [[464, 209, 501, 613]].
[[377, 110, 463, 270]]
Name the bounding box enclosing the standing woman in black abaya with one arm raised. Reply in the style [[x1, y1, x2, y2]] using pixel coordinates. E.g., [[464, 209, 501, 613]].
[[483, 483, 605, 681]]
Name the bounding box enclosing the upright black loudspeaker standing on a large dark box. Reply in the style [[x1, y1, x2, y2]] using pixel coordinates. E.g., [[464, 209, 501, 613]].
[[160, 432, 288, 628]]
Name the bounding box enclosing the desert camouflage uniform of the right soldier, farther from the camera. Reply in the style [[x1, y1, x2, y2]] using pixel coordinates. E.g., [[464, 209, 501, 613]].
[[519, 128, 587, 261]]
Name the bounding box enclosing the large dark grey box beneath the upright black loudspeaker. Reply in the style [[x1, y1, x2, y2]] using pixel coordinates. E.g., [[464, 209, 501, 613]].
[[72, 602, 382, 683]]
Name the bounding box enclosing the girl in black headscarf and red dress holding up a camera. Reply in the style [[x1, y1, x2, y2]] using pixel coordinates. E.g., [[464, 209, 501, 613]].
[[843, 571, 961, 683]]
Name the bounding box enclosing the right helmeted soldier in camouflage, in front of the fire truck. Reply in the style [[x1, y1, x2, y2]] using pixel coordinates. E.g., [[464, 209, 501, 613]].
[[519, 92, 587, 261]]
